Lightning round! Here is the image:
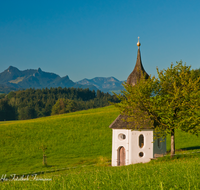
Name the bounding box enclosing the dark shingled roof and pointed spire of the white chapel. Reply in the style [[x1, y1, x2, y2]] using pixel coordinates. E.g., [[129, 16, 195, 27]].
[[109, 43, 152, 129]]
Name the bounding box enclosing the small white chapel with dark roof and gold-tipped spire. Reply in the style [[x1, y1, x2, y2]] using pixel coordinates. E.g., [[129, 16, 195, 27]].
[[109, 37, 166, 166]]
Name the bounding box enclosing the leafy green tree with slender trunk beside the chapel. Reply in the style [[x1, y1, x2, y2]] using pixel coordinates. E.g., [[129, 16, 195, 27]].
[[116, 61, 200, 157]]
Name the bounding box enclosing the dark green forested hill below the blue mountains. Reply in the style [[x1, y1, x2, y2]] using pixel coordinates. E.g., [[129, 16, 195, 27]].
[[0, 87, 118, 121]]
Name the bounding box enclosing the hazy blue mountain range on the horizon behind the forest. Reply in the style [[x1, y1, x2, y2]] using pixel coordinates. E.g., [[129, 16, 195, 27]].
[[0, 66, 123, 93]]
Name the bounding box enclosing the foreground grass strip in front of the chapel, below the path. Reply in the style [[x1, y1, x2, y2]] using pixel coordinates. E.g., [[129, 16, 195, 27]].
[[0, 154, 200, 190]]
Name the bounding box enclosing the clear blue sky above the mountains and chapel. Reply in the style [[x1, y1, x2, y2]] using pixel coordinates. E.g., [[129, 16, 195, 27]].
[[0, 0, 200, 81]]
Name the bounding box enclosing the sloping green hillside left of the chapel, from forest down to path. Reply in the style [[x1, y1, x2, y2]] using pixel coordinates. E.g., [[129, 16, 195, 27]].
[[0, 107, 118, 174]]
